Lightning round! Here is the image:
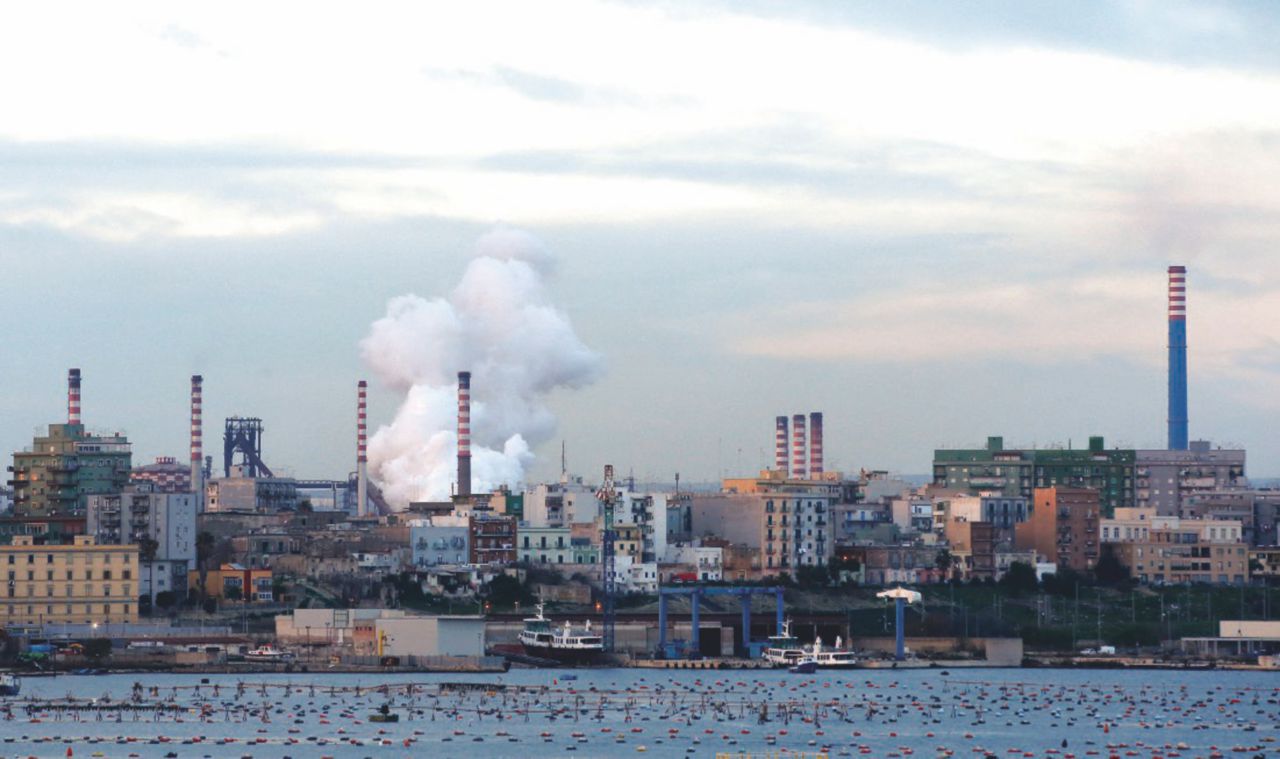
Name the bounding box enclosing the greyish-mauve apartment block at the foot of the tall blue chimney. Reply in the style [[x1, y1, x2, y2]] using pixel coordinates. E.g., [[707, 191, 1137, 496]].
[[1135, 440, 1248, 517]]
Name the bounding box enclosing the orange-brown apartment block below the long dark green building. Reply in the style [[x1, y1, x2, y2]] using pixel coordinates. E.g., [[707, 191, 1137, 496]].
[[1014, 486, 1101, 572]]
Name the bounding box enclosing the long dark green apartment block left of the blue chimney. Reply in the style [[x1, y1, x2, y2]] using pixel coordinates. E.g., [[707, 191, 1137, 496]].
[[933, 438, 1137, 516]]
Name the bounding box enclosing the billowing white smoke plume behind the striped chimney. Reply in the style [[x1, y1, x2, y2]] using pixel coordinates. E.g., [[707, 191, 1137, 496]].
[[360, 229, 602, 509]]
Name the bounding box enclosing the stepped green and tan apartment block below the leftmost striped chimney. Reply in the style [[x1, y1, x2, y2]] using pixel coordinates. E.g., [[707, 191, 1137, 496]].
[[9, 424, 133, 517]]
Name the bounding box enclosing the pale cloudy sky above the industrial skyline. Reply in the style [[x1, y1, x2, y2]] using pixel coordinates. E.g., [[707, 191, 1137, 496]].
[[0, 0, 1280, 481]]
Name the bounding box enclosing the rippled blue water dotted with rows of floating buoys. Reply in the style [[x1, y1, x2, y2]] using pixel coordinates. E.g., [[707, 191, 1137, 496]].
[[0, 669, 1280, 759]]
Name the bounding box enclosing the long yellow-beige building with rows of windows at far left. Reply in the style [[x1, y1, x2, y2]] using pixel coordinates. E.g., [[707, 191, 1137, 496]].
[[0, 535, 140, 625]]
